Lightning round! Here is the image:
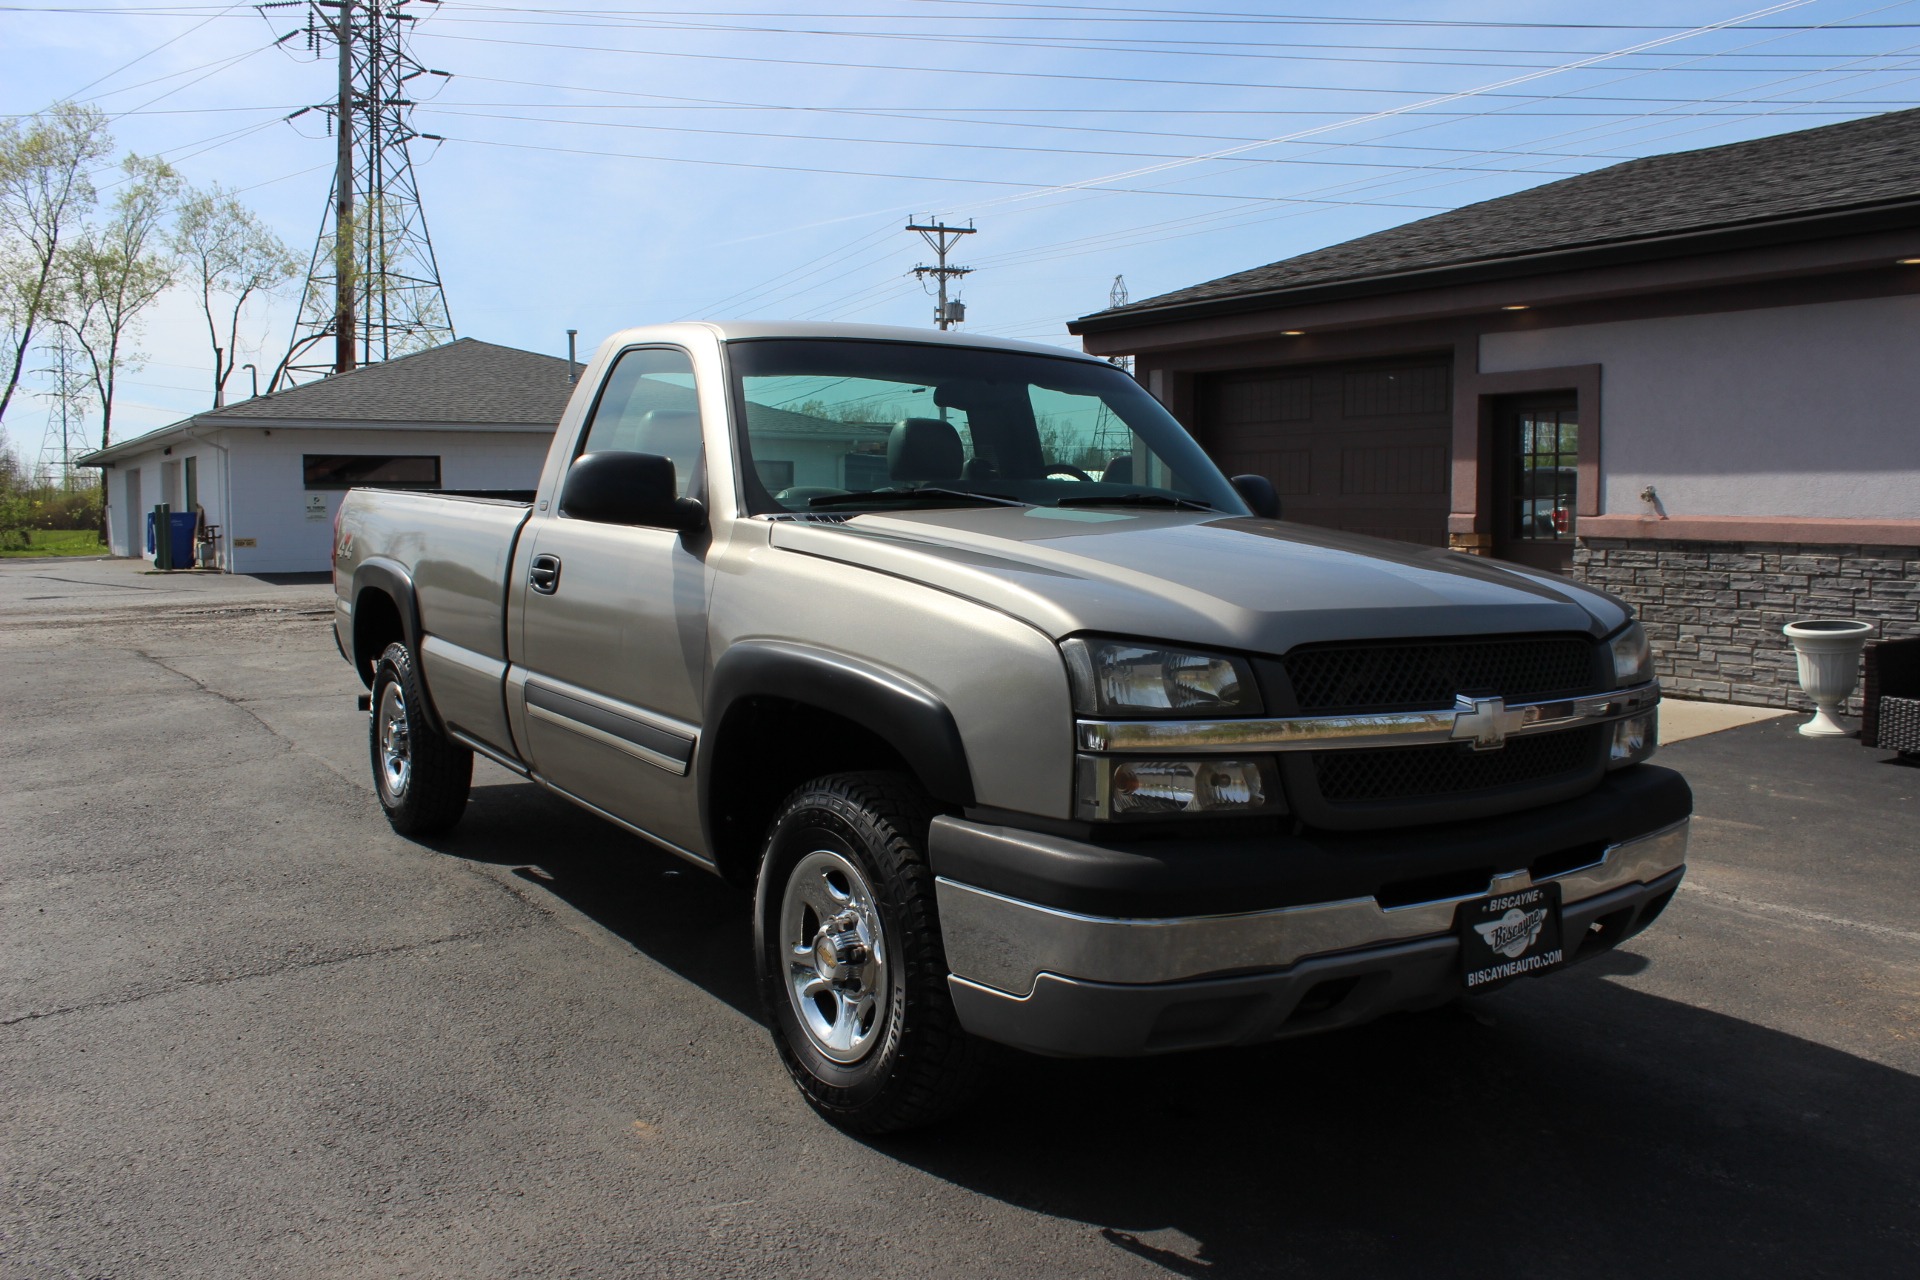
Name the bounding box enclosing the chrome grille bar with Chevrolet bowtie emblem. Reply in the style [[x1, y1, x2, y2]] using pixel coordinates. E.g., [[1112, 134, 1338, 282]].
[[1073, 681, 1661, 754]]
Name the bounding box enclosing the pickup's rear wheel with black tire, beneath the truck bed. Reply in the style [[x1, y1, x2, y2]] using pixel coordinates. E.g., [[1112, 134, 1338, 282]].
[[367, 641, 474, 835]]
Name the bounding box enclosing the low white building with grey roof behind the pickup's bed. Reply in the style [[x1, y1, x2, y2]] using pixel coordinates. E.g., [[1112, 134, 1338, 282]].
[[81, 338, 572, 574]]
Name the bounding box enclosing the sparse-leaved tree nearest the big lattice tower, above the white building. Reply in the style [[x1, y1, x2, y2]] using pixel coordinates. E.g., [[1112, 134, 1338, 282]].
[[169, 182, 300, 409]]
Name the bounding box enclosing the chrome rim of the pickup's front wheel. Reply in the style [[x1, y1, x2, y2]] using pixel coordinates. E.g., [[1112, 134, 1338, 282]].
[[780, 848, 891, 1063]]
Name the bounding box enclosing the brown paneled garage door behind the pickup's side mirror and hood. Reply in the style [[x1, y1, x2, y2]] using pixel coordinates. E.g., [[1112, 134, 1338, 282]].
[[1194, 357, 1453, 547]]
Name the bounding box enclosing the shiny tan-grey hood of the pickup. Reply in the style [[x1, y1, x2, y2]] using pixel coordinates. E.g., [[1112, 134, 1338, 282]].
[[770, 507, 1628, 652]]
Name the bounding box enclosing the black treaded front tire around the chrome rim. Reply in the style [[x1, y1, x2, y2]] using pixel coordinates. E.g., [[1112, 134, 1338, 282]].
[[755, 773, 989, 1134]]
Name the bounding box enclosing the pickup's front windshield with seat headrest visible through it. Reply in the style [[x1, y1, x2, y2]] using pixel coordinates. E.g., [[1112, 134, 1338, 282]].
[[728, 338, 1246, 516]]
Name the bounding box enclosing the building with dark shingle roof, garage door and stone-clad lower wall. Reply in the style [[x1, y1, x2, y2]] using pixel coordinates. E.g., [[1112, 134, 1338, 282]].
[[1069, 109, 1920, 704]]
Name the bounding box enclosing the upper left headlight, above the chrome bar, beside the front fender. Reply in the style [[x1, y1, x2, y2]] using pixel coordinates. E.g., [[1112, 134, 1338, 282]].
[[1060, 639, 1260, 716]]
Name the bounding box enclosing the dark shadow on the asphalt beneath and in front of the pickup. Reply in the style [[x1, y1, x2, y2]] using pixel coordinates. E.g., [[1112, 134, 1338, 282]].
[[445, 783, 1920, 1280]]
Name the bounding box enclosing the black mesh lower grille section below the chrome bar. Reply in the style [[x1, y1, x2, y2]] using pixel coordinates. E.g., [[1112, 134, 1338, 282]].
[[1313, 725, 1609, 804]]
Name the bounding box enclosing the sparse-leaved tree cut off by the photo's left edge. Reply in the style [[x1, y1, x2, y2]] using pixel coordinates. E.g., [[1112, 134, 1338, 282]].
[[0, 102, 113, 429]]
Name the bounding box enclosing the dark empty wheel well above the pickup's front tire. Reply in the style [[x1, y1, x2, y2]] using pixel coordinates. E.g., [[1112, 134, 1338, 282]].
[[707, 697, 914, 887]]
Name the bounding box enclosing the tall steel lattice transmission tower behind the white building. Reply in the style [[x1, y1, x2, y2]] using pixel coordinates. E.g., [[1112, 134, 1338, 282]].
[[267, 0, 453, 391]]
